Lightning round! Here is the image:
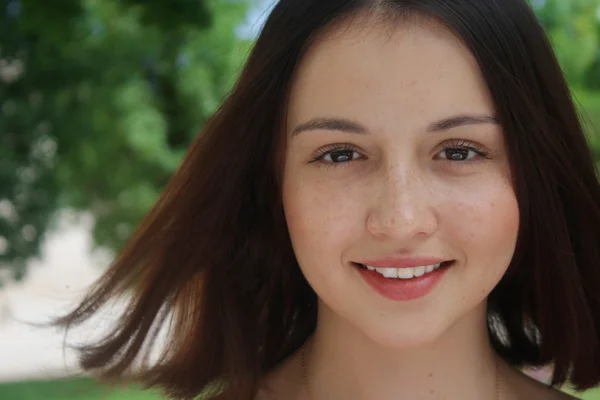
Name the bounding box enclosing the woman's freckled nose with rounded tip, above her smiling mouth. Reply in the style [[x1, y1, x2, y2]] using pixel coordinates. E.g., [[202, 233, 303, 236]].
[[367, 168, 438, 242]]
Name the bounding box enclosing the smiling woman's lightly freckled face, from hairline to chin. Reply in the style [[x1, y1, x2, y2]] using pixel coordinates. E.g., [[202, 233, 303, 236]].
[[283, 18, 519, 347]]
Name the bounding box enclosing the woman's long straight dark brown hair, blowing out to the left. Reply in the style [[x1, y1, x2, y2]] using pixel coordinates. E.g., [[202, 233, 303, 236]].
[[58, 0, 600, 400]]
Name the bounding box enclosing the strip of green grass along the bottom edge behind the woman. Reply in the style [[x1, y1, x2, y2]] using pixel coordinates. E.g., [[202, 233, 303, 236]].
[[0, 378, 600, 400]]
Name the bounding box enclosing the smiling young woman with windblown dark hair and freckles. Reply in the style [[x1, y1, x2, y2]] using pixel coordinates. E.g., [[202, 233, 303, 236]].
[[60, 0, 600, 400]]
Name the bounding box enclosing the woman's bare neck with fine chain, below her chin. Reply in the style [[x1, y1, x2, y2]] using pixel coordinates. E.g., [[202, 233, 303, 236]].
[[305, 304, 497, 400]]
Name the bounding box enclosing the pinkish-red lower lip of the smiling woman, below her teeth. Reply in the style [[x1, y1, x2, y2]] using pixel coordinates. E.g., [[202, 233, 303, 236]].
[[355, 263, 454, 301]]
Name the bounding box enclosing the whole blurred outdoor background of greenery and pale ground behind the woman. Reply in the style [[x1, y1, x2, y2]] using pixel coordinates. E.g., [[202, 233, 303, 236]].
[[0, 0, 600, 400]]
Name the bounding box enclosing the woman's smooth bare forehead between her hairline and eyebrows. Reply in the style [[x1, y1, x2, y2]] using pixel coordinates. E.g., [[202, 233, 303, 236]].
[[288, 14, 493, 131]]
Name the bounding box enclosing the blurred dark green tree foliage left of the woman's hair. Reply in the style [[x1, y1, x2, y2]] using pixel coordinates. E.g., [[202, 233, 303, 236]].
[[0, 0, 249, 279]]
